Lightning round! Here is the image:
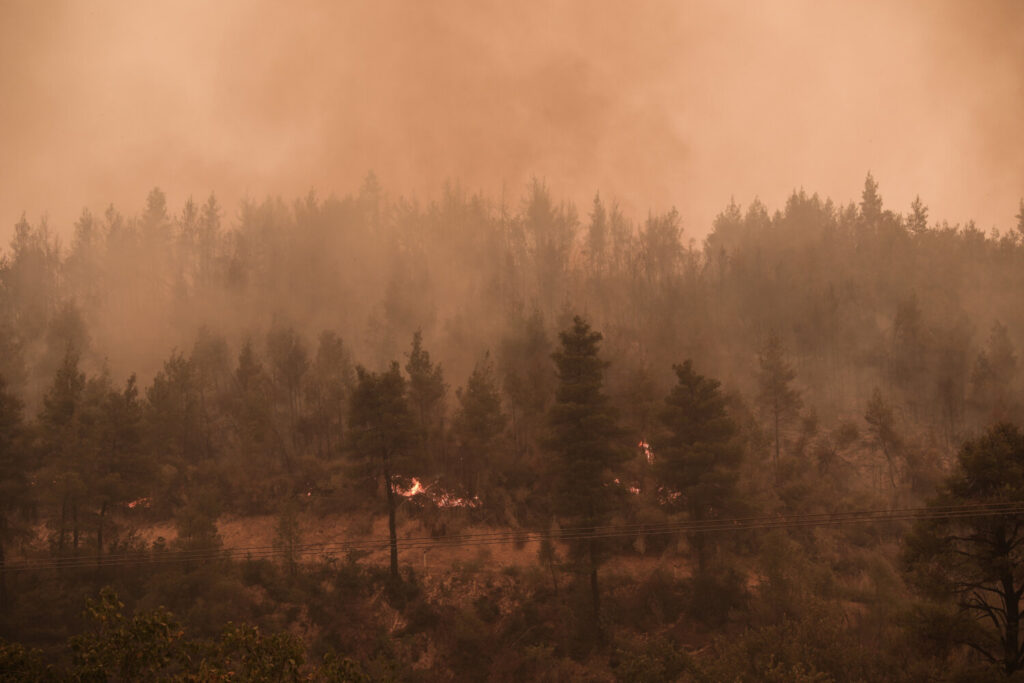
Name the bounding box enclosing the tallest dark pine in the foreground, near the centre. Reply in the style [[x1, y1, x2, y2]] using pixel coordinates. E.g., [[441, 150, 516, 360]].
[[548, 315, 627, 638]]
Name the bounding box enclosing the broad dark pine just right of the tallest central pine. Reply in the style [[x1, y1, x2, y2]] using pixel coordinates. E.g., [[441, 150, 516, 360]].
[[654, 360, 742, 572]]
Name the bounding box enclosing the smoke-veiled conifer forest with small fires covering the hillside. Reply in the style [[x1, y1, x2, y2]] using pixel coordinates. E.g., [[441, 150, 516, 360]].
[[0, 174, 1024, 683]]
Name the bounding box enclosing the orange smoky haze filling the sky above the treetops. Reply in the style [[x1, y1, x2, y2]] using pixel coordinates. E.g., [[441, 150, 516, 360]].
[[0, 0, 1024, 238]]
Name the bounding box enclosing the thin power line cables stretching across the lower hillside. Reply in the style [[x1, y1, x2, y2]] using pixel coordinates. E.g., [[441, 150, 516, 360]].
[[5, 502, 1024, 571]]
